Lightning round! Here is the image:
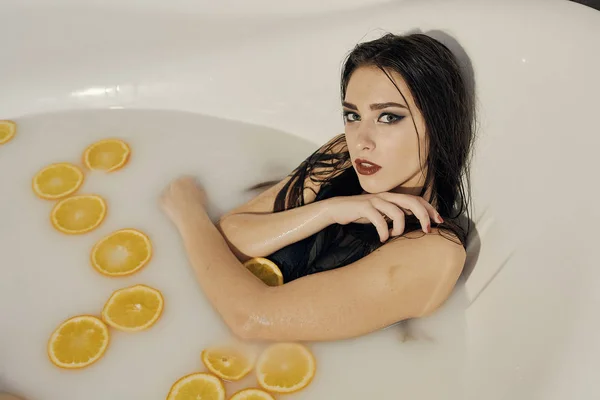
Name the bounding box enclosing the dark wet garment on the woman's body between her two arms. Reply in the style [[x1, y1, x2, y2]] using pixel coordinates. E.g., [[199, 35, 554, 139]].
[[267, 184, 381, 283]]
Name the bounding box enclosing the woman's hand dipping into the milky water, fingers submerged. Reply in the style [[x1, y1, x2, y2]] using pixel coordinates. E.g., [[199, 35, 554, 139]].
[[160, 176, 206, 227]]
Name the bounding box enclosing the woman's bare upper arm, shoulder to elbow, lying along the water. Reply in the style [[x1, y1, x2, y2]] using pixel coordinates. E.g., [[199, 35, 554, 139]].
[[241, 230, 465, 341]]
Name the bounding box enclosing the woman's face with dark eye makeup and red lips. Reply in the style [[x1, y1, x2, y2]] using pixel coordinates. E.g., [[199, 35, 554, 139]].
[[343, 67, 427, 195]]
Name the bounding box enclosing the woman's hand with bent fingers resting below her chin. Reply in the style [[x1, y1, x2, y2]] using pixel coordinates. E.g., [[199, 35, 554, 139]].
[[326, 192, 444, 242]]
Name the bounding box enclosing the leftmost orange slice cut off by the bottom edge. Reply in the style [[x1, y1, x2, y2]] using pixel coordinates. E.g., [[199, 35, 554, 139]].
[[167, 372, 225, 400]]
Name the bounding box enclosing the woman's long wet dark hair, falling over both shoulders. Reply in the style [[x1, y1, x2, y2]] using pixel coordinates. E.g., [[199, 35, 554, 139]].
[[274, 33, 475, 247]]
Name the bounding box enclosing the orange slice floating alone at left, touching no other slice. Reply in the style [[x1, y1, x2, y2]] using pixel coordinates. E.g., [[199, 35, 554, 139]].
[[91, 229, 152, 276]]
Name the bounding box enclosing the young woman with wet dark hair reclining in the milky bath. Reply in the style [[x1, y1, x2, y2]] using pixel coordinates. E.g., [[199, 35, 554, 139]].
[[161, 34, 474, 341]]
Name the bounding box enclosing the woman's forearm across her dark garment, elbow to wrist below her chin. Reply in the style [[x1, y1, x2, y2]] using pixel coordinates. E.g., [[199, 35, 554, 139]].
[[219, 200, 333, 259]]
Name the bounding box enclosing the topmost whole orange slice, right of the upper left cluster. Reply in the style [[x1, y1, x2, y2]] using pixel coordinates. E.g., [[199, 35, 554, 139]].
[[83, 139, 131, 172]]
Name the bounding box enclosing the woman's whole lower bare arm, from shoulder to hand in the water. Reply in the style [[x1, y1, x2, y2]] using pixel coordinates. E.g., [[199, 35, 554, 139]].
[[163, 182, 465, 341]]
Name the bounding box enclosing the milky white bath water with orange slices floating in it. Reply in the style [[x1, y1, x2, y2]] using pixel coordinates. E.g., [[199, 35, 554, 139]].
[[0, 110, 466, 400]]
